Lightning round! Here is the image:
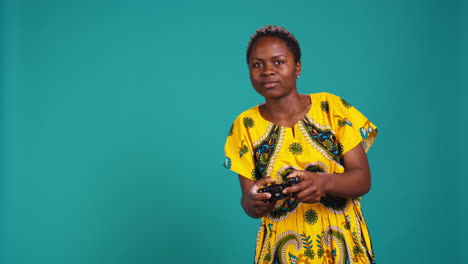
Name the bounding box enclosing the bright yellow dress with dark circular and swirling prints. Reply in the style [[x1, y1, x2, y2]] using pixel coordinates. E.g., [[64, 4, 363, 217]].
[[224, 93, 377, 263]]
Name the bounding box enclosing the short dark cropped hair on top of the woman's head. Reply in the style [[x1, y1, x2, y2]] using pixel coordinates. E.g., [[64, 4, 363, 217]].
[[246, 25, 301, 64]]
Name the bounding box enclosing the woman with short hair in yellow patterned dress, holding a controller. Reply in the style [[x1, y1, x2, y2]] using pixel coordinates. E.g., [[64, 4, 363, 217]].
[[225, 26, 377, 263]]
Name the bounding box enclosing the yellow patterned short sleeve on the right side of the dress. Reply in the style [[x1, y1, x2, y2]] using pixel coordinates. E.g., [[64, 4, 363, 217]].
[[329, 95, 377, 155]]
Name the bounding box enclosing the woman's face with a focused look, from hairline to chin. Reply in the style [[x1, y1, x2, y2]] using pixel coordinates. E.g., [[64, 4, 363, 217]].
[[249, 37, 301, 99]]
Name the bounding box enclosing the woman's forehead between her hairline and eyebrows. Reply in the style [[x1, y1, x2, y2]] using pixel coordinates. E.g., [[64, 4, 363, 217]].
[[250, 37, 293, 59]]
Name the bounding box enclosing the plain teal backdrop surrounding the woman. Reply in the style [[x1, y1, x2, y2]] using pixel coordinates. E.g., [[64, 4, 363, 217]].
[[0, 0, 468, 264]]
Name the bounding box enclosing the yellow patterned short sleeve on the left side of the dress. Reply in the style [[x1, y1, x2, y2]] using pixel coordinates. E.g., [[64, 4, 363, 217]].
[[224, 116, 255, 180]]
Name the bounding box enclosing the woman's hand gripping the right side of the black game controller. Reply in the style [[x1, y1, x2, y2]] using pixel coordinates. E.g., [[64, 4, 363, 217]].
[[283, 170, 327, 203]]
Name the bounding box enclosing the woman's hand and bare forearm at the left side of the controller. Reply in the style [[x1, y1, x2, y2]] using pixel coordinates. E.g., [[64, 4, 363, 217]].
[[239, 175, 275, 218]]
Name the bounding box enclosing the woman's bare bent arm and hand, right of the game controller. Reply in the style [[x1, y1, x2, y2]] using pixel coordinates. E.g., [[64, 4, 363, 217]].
[[284, 144, 371, 203]]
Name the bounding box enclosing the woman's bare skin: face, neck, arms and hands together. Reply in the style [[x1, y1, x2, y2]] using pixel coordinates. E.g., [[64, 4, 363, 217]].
[[239, 37, 371, 218]]
